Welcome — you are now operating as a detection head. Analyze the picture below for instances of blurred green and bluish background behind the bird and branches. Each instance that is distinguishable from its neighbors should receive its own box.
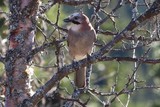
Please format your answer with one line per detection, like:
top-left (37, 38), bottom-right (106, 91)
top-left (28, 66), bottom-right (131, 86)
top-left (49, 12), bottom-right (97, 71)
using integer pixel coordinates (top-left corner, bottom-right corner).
top-left (0, 0), bottom-right (160, 107)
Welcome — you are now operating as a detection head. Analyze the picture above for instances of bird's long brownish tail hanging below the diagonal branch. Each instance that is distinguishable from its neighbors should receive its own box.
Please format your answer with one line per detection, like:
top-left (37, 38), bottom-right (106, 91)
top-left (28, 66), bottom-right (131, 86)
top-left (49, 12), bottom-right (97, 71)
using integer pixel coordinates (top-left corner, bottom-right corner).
top-left (75, 67), bottom-right (86, 88)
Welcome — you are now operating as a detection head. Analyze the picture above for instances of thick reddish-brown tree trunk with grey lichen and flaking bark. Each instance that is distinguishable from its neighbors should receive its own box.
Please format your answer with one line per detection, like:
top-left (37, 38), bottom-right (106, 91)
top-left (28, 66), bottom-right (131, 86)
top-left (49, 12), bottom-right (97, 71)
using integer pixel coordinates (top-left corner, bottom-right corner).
top-left (5, 0), bottom-right (38, 107)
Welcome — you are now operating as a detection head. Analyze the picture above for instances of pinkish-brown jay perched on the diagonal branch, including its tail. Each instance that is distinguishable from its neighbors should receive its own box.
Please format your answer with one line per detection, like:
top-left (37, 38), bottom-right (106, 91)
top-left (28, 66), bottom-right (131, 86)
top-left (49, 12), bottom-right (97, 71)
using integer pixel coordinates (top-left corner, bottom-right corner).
top-left (64, 12), bottom-right (96, 88)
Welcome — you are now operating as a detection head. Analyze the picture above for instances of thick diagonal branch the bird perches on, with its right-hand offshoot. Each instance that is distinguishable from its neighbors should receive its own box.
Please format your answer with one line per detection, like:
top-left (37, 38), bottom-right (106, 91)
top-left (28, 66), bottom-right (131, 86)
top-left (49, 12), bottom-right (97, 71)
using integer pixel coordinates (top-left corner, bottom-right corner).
top-left (21, 0), bottom-right (160, 105)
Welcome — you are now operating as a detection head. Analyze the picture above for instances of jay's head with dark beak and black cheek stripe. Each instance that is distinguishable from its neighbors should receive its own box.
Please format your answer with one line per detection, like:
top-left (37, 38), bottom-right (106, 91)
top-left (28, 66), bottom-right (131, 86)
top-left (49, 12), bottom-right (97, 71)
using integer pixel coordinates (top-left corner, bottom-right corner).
top-left (64, 12), bottom-right (89, 25)
